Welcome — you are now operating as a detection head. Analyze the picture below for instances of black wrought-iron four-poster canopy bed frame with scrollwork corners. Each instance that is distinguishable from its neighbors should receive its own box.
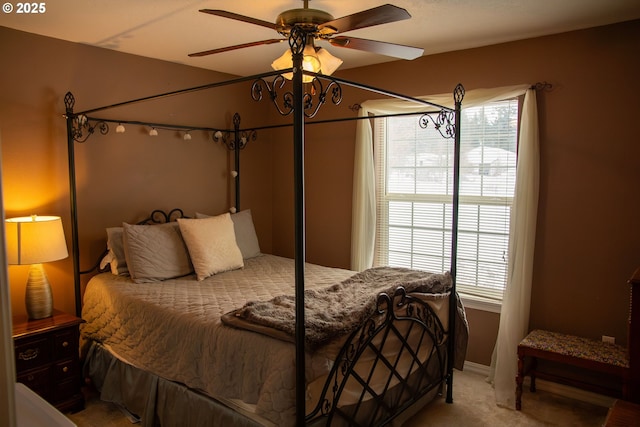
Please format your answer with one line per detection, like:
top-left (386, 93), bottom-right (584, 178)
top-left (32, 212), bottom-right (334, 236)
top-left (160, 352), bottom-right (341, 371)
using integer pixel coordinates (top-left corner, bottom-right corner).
top-left (64, 28), bottom-right (464, 425)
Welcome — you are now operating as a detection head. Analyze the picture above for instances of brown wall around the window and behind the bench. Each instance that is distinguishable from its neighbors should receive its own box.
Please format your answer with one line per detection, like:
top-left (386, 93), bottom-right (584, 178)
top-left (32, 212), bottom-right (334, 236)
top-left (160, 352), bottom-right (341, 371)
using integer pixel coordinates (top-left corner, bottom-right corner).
top-left (274, 21), bottom-right (640, 364)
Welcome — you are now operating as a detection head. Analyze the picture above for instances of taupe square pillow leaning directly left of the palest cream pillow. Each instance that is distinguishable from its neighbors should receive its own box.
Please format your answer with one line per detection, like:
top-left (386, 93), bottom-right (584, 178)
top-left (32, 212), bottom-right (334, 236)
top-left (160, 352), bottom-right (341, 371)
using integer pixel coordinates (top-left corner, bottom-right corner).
top-left (122, 222), bottom-right (193, 283)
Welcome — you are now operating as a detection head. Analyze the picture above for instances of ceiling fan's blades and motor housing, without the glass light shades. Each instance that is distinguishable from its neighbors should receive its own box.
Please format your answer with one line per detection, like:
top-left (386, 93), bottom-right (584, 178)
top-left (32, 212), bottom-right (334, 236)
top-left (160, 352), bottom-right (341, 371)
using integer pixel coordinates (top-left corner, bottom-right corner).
top-left (189, 0), bottom-right (423, 59)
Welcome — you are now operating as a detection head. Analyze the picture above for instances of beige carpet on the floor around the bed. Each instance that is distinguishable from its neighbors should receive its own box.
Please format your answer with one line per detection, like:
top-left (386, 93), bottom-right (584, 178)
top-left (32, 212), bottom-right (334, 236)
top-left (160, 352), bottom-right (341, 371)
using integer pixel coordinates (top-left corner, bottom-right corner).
top-left (67, 371), bottom-right (608, 427)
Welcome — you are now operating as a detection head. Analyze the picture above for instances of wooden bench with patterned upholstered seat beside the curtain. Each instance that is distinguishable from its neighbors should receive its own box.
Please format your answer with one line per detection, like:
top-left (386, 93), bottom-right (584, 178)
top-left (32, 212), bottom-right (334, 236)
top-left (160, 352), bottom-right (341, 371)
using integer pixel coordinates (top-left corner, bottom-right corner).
top-left (516, 330), bottom-right (630, 410)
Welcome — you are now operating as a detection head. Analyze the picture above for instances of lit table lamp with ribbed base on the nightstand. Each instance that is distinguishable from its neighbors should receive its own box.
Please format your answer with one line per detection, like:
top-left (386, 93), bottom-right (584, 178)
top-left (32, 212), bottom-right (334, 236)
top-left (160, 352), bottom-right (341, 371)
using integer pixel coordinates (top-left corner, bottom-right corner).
top-left (5, 215), bottom-right (69, 319)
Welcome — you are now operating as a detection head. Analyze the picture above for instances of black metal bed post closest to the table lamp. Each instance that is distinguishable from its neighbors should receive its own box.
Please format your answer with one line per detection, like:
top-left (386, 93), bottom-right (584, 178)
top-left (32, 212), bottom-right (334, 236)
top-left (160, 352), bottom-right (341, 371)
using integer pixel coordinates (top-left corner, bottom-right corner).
top-left (64, 92), bottom-right (82, 317)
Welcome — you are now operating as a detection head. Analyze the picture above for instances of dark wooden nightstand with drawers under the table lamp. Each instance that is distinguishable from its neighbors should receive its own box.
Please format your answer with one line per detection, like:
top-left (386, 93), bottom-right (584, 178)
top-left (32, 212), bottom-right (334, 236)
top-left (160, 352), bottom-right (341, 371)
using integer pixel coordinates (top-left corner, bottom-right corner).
top-left (13, 310), bottom-right (84, 412)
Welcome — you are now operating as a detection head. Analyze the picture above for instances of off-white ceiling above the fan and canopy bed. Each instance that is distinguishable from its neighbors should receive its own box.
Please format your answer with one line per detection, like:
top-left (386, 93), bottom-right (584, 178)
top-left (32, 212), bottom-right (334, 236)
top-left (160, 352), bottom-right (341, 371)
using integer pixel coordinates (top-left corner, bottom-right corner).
top-left (0, 0), bottom-right (640, 76)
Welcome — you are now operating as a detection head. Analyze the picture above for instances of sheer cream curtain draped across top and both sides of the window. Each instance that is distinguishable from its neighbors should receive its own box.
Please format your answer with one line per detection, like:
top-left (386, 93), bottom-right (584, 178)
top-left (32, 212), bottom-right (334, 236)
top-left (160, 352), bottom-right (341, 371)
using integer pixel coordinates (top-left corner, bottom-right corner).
top-left (351, 85), bottom-right (539, 406)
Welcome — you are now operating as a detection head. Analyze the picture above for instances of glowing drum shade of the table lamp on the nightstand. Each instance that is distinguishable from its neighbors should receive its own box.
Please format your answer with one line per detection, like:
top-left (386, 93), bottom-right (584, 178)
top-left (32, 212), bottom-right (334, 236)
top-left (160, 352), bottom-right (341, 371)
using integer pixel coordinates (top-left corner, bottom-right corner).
top-left (5, 215), bottom-right (69, 265)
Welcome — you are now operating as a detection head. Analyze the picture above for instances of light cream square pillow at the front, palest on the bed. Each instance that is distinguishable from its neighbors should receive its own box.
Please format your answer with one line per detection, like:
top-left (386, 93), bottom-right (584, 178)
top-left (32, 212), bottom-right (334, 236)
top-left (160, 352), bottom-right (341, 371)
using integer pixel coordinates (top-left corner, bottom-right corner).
top-left (178, 213), bottom-right (244, 280)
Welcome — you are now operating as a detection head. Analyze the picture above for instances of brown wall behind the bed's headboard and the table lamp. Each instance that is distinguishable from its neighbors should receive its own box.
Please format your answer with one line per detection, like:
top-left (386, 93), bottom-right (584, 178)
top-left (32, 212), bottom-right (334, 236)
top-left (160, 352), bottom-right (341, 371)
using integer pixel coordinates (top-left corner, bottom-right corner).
top-left (0, 27), bottom-right (271, 314)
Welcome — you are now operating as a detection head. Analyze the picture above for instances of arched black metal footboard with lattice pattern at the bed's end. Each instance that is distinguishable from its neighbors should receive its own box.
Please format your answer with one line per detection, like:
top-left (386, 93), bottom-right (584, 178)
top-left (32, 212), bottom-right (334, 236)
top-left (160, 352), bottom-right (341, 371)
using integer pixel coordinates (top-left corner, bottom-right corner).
top-left (306, 287), bottom-right (449, 427)
